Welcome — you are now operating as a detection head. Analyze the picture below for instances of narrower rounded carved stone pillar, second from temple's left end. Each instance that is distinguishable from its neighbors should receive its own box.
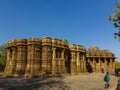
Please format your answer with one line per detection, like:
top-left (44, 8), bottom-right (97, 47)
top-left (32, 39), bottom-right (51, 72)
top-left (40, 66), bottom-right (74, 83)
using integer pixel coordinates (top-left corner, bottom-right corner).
top-left (16, 39), bottom-right (27, 75)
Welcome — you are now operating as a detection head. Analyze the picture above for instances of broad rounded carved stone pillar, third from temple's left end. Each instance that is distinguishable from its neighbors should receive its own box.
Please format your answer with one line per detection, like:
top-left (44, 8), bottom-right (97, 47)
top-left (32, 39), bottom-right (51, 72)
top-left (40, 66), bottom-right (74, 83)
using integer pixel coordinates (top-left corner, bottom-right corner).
top-left (25, 38), bottom-right (42, 76)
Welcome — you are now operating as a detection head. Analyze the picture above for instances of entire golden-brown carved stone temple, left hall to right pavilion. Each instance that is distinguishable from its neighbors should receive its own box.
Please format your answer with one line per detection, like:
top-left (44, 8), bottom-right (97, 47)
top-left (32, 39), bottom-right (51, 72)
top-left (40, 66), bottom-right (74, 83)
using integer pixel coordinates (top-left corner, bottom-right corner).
top-left (4, 37), bottom-right (115, 77)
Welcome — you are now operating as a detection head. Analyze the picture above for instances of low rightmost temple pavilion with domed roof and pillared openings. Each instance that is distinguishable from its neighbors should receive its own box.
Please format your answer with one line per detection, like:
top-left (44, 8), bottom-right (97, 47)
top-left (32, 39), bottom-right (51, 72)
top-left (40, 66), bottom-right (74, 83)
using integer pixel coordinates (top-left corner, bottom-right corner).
top-left (86, 46), bottom-right (115, 73)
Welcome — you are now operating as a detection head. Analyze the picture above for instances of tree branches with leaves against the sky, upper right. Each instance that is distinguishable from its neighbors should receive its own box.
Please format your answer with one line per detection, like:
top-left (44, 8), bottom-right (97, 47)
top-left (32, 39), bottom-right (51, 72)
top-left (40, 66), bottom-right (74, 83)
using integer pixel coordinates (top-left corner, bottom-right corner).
top-left (109, 2), bottom-right (120, 41)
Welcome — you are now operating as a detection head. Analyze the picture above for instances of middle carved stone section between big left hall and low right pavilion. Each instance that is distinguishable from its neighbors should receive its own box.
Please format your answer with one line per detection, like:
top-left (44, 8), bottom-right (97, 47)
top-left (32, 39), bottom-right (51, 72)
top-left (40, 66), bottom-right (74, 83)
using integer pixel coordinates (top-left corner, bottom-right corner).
top-left (69, 44), bottom-right (86, 75)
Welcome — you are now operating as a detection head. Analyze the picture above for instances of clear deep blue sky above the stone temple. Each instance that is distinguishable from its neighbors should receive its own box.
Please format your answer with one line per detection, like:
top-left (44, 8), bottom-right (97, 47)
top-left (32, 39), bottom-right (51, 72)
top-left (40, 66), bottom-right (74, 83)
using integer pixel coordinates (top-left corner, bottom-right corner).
top-left (0, 0), bottom-right (120, 58)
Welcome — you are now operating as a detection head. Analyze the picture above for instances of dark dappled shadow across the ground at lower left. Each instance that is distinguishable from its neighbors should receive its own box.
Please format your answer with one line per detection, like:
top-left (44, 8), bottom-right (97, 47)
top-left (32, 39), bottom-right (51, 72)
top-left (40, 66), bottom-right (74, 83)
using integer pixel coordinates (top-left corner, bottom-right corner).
top-left (0, 76), bottom-right (70, 90)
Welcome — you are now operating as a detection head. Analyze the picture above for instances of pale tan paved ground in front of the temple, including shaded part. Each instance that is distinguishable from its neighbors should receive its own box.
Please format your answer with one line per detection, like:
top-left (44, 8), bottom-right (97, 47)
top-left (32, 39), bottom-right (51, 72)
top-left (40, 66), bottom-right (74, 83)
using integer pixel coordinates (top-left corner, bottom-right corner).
top-left (0, 73), bottom-right (117, 90)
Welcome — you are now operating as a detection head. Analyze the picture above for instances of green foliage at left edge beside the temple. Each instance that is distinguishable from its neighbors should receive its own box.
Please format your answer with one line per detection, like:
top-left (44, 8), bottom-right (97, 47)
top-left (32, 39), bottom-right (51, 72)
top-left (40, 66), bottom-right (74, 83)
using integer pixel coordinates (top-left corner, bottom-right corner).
top-left (0, 44), bottom-right (6, 71)
